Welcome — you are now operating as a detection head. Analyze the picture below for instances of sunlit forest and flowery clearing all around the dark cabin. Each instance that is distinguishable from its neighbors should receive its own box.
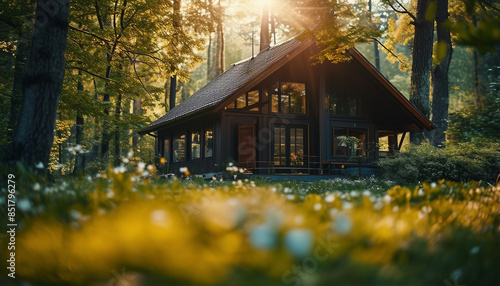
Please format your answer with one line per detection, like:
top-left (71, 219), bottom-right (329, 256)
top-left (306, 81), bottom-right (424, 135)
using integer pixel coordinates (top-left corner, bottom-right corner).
top-left (0, 0), bottom-right (500, 286)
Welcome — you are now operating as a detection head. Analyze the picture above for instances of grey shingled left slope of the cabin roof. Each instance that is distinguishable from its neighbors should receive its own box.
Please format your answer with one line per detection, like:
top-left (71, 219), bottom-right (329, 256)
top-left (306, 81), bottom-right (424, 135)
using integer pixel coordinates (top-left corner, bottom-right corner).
top-left (140, 37), bottom-right (312, 133)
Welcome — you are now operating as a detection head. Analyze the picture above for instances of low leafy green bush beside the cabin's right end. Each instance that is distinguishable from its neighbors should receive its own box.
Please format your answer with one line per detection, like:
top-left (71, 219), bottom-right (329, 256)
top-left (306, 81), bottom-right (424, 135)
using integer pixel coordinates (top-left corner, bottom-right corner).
top-left (379, 142), bottom-right (500, 184)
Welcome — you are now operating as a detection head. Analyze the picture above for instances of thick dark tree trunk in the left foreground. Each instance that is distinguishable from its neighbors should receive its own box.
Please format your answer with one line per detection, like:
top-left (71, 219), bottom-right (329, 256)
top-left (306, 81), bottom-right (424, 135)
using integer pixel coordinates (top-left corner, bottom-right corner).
top-left (11, 0), bottom-right (69, 168)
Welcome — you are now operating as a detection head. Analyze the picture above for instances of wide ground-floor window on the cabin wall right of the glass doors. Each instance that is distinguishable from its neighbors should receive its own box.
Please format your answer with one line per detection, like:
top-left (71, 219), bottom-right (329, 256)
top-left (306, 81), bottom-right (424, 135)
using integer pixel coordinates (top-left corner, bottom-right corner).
top-left (333, 127), bottom-right (368, 157)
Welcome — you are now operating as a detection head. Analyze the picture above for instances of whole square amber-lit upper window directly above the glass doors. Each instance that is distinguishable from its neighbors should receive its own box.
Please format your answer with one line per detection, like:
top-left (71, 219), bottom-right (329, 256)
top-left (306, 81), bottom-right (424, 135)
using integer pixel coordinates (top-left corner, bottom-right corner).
top-left (271, 82), bottom-right (306, 114)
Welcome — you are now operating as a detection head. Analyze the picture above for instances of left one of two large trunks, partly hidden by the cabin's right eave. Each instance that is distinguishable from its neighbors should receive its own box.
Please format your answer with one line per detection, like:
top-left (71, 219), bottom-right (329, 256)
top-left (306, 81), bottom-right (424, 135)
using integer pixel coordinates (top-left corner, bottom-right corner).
top-left (410, 0), bottom-right (434, 145)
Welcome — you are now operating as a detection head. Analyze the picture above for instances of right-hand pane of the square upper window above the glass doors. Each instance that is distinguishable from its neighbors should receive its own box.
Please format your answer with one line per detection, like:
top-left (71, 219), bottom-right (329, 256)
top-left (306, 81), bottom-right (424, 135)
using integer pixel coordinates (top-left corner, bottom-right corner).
top-left (281, 82), bottom-right (306, 114)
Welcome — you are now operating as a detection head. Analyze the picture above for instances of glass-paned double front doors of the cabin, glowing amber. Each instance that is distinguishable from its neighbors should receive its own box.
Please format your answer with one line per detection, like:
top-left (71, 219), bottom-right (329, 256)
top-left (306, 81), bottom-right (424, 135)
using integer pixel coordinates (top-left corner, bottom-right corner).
top-left (272, 125), bottom-right (308, 174)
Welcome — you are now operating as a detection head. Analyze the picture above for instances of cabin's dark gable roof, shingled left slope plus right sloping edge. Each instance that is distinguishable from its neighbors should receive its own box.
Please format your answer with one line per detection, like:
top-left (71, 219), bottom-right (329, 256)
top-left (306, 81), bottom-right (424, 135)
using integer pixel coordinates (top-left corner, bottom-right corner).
top-left (139, 37), bottom-right (435, 134)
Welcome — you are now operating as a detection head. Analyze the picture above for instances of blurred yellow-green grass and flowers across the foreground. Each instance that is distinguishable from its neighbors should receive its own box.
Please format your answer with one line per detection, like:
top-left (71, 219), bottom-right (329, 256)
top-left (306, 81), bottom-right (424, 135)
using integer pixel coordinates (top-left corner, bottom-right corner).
top-left (0, 166), bottom-right (500, 286)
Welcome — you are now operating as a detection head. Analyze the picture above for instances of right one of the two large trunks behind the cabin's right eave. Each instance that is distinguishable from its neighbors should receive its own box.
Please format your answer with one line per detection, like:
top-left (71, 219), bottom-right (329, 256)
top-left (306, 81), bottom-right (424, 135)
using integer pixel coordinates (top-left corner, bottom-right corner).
top-left (430, 0), bottom-right (453, 147)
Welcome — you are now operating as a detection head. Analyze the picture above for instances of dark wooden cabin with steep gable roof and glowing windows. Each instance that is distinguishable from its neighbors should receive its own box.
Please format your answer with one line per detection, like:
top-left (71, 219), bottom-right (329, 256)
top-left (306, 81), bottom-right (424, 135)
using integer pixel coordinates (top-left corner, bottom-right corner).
top-left (140, 38), bottom-right (434, 174)
